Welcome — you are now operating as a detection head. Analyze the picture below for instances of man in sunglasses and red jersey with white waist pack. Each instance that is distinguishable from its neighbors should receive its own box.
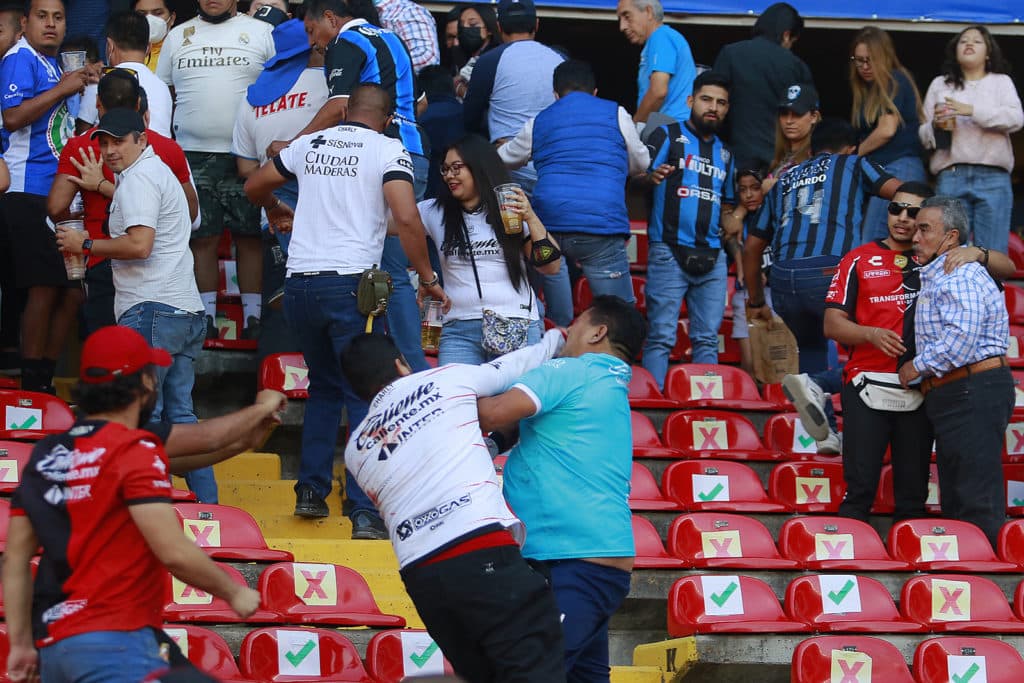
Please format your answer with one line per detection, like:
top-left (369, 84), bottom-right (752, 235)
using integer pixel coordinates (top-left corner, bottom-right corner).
top-left (824, 182), bottom-right (1014, 521)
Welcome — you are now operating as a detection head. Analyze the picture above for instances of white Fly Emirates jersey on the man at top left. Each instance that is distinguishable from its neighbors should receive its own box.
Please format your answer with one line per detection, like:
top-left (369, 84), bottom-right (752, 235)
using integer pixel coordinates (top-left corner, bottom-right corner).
top-left (157, 14), bottom-right (274, 153)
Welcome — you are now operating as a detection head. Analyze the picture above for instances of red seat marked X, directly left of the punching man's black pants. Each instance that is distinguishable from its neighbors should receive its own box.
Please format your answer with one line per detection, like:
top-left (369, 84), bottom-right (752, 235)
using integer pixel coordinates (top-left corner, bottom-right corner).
top-left (259, 562), bottom-right (406, 629)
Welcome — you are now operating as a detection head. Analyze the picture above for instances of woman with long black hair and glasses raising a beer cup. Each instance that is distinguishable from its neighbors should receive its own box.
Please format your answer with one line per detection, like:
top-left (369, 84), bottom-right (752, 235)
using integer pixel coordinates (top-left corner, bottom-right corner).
top-left (419, 135), bottom-right (561, 365)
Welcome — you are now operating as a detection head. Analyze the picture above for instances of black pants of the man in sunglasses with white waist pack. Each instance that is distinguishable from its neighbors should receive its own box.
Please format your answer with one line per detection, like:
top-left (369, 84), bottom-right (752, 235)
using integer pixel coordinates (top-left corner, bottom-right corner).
top-left (839, 383), bottom-right (933, 521)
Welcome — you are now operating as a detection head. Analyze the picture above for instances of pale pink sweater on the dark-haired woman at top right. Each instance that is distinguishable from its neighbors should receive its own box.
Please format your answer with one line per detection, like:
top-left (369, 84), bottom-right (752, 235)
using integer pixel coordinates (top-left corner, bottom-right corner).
top-left (918, 74), bottom-right (1024, 173)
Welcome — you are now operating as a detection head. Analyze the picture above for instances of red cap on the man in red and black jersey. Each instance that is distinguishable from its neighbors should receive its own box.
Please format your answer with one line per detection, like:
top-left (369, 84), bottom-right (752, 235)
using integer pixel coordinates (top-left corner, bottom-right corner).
top-left (79, 325), bottom-right (171, 384)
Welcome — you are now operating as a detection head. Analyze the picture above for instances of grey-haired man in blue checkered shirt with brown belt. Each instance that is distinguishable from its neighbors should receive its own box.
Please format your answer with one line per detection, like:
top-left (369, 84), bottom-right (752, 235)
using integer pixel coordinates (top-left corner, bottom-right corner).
top-left (899, 197), bottom-right (1014, 547)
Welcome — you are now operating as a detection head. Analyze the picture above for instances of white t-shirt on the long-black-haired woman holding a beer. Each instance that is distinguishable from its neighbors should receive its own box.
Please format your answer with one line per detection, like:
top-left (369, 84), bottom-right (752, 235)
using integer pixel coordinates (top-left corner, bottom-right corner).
top-left (418, 200), bottom-right (541, 321)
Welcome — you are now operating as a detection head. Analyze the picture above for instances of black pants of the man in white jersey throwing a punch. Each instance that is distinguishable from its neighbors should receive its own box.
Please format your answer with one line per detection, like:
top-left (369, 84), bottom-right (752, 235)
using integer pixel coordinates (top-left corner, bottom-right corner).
top-left (401, 546), bottom-right (565, 683)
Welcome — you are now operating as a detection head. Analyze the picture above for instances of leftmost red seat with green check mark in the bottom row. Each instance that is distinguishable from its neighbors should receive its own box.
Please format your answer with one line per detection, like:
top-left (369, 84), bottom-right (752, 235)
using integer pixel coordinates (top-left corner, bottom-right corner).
top-left (239, 628), bottom-right (375, 683)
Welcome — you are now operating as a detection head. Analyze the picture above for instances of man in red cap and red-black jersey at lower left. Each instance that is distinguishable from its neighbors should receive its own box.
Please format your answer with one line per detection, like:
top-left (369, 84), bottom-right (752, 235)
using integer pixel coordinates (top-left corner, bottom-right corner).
top-left (3, 327), bottom-right (259, 683)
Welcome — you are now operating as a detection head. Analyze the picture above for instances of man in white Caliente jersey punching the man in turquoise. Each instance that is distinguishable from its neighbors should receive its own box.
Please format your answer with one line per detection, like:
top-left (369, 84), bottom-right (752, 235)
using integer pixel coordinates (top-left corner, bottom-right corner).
top-left (341, 330), bottom-right (565, 683)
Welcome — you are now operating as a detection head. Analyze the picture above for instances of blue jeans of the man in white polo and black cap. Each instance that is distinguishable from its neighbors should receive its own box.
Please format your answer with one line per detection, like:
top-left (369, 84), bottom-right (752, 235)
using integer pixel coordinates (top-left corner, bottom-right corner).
top-left (118, 301), bottom-right (211, 504)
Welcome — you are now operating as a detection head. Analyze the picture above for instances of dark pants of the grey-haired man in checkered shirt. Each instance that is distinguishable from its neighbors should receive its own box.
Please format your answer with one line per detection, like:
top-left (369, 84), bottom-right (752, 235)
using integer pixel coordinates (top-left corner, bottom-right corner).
top-left (925, 368), bottom-right (1014, 548)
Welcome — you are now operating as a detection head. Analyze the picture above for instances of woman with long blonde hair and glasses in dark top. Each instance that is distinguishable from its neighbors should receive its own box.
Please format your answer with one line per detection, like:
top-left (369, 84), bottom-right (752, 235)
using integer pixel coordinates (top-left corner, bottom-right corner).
top-left (850, 27), bottom-right (926, 242)
